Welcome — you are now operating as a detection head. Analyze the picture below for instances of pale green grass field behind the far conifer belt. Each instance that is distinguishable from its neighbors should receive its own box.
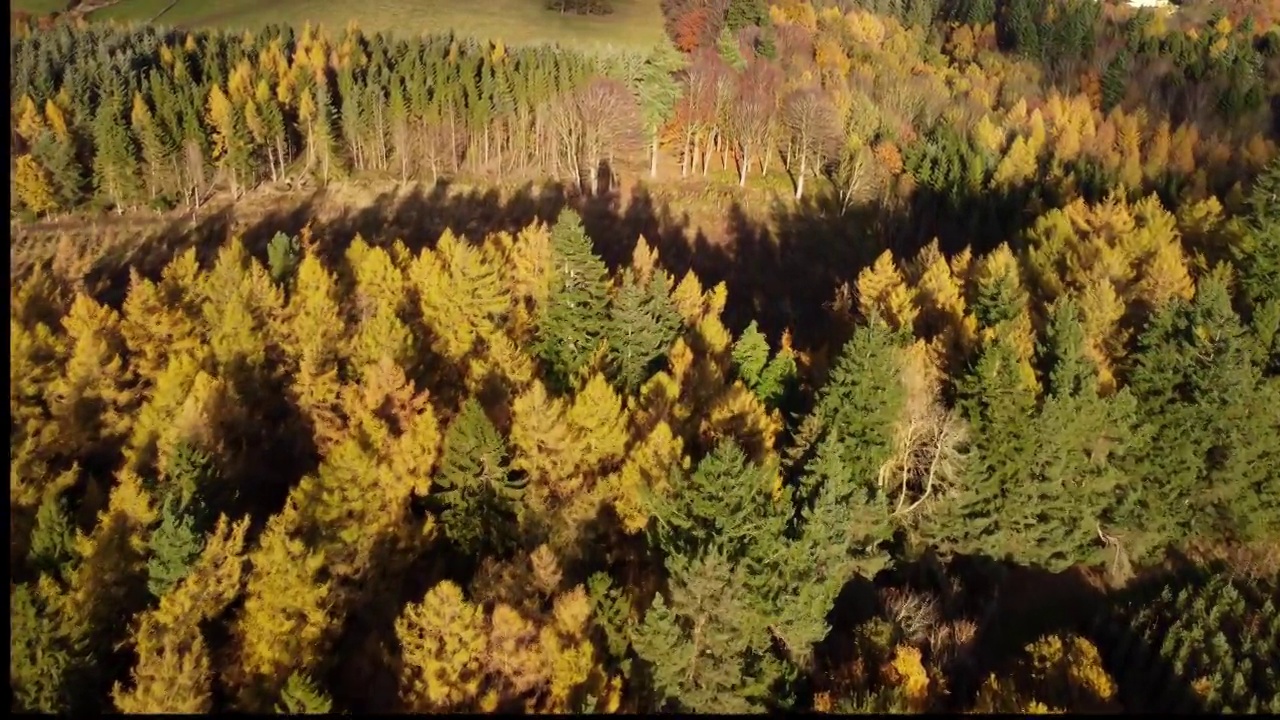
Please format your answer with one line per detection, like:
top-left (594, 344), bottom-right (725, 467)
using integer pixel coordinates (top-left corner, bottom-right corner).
top-left (12, 0), bottom-right (663, 49)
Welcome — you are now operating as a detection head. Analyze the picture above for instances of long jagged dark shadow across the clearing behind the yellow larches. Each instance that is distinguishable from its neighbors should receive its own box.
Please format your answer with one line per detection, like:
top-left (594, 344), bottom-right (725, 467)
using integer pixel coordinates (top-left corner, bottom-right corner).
top-left (91, 171), bottom-right (1049, 348)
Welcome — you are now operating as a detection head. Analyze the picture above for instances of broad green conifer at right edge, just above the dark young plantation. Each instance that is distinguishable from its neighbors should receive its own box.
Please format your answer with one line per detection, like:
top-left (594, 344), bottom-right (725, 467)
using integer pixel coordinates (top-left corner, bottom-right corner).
top-left (1117, 274), bottom-right (1280, 556)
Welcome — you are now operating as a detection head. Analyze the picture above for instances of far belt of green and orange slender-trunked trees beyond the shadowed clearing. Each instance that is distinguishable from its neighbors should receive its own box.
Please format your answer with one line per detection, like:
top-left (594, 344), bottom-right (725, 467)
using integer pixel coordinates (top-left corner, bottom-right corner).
top-left (10, 1), bottom-right (1275, 214)
